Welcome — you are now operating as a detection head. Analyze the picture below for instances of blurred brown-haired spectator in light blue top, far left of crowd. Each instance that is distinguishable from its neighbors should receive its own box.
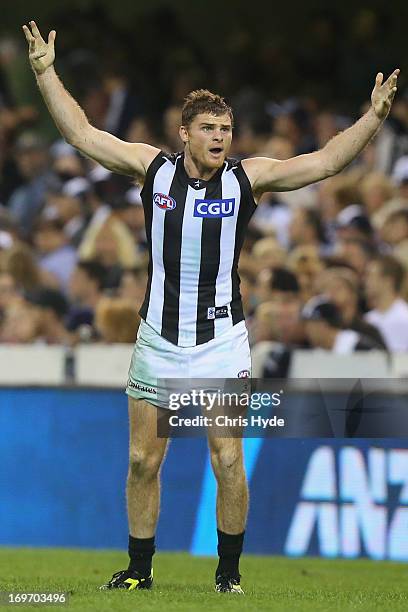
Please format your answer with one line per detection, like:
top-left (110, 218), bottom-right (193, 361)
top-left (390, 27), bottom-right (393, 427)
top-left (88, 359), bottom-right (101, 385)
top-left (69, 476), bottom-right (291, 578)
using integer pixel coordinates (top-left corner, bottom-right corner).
top-left (33, 218), bottom-right (77, 293)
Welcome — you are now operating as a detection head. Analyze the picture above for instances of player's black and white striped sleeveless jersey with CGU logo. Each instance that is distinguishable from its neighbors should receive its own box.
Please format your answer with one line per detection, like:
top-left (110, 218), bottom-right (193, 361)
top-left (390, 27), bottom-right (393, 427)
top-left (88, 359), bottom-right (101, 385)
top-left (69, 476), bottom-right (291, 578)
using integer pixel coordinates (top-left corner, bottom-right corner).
top-left (139, 151), bottom-right (256, 347)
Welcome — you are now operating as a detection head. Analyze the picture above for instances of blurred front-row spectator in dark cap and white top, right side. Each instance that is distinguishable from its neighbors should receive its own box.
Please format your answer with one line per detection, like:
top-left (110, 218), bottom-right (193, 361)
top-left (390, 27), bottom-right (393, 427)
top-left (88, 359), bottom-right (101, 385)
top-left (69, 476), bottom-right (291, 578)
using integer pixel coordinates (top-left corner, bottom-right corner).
top-left (301, 296), bottom-right (378, 355)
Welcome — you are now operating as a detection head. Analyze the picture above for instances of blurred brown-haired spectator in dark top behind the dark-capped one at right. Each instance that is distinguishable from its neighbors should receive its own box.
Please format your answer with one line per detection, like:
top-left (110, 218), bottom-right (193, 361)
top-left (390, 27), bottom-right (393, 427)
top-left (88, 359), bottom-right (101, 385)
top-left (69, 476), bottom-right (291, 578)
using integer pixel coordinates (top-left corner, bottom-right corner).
top-left (317, 267), bottom-right (386, 350)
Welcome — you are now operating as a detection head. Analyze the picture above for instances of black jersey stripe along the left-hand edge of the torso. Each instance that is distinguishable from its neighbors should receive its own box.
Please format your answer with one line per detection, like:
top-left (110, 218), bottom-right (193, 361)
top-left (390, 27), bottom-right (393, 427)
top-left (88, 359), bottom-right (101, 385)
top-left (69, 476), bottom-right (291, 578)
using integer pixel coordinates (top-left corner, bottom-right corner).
top-left (139, 151), bottom-right (167, 319)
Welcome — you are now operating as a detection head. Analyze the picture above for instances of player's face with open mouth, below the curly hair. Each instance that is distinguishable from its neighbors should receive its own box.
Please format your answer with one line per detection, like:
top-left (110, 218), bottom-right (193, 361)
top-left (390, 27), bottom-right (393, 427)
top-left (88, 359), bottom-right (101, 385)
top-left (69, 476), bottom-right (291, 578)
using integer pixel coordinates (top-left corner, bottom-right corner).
top-left (180, 113), bottom-right (232, 169)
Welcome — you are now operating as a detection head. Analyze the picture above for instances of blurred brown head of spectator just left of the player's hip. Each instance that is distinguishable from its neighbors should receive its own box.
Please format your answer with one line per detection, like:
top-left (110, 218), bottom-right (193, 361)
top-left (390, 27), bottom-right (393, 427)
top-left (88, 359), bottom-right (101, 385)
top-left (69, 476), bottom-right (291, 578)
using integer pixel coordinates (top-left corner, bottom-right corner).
top-left (95, 297), bottom-right (140, 344)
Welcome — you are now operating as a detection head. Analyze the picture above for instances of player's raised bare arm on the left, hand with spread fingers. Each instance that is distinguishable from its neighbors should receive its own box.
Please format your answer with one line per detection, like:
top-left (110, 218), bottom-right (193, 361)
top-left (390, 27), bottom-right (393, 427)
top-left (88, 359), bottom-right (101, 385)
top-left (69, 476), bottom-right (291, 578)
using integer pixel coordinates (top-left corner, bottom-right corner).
top-left (23, 21), bottom-right (159, 180)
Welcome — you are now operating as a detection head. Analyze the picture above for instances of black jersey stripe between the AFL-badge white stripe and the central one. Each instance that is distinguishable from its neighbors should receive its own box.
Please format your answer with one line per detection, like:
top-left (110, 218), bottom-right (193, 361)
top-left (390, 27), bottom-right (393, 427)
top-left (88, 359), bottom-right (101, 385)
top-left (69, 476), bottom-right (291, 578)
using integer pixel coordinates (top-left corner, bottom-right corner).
top-left (161, 157), bottom-right (188, 344)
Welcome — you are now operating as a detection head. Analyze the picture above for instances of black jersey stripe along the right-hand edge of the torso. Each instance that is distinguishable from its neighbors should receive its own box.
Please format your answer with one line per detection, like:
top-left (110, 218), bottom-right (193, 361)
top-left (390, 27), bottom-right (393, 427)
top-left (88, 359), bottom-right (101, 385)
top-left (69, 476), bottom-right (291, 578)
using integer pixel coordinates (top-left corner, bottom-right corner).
top-left (231, 162), bottom-right (256, 325)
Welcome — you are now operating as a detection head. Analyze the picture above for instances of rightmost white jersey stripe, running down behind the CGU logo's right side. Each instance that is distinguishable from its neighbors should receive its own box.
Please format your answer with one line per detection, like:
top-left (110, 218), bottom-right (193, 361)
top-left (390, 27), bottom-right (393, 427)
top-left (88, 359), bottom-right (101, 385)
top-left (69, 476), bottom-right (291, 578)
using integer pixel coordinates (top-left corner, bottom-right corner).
top-left (214, 165), bottom-right (241, 336)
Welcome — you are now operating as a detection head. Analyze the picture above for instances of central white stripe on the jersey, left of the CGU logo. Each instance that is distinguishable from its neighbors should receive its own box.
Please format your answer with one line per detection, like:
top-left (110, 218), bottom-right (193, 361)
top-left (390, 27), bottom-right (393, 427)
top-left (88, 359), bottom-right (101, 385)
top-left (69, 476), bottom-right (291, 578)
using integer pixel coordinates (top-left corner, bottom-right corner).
top-left (179, 185), bottom-right (206, 346)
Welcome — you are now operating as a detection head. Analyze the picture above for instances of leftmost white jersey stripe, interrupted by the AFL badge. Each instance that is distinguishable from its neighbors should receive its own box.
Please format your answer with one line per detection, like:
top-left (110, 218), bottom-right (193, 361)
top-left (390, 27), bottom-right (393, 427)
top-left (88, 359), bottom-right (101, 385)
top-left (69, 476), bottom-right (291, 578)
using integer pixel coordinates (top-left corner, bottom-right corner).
top-left (146, 158), bottom-right (178, 333)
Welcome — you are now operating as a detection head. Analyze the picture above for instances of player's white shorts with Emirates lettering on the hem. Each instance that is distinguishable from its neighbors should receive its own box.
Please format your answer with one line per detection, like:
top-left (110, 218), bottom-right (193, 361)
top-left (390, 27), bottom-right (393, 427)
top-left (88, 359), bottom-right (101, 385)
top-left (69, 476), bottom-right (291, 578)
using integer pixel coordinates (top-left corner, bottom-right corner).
top-left (126, 319), bottom-right (251, 408)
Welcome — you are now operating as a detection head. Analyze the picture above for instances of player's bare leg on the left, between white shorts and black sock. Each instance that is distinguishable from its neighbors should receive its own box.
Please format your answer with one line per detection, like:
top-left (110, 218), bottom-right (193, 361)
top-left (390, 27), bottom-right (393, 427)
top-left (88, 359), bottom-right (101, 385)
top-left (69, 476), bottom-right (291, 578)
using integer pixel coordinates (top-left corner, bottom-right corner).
top-left (126, 397), bottom-right (168, 538)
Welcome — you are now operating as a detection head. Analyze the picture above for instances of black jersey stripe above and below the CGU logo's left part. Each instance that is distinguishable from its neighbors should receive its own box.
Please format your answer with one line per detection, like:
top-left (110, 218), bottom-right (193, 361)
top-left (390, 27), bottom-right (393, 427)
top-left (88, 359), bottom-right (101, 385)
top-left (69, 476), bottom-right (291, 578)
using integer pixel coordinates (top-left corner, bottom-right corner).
top-left (196, 178), bottom-right (222, 344)
